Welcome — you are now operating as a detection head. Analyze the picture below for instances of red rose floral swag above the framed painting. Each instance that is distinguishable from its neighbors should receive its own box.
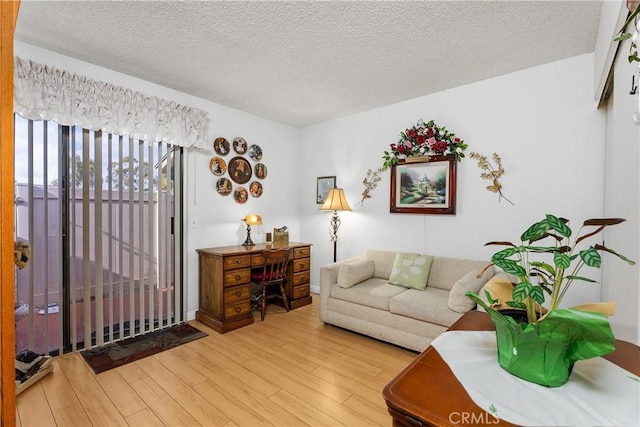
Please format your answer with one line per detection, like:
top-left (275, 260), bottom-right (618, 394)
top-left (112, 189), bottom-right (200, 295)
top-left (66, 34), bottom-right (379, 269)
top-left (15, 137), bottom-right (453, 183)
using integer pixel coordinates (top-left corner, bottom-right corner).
top-left (382, 119), bottom-right (467, 169)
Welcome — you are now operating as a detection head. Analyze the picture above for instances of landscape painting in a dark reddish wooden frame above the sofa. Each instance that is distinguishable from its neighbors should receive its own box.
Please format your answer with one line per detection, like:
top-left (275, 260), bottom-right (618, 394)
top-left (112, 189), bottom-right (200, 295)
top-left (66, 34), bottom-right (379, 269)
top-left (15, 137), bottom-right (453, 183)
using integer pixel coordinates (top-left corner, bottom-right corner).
top-left (389, 155), bottom-right (457, 215)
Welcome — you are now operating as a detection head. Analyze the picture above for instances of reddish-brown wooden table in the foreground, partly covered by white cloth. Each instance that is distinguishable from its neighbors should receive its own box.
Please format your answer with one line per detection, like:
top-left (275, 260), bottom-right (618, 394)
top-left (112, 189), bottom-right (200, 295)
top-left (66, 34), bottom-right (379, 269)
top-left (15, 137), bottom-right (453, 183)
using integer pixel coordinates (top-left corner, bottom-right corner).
top-left (382, 311), bottom-right (640, 427)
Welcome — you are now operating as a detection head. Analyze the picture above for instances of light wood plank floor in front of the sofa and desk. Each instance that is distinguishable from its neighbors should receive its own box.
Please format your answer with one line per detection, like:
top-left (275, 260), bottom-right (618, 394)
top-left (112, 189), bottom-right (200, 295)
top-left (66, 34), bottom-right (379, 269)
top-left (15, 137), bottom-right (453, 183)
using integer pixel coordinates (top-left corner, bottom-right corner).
top-left (16, 295), bottom-right (417, 427)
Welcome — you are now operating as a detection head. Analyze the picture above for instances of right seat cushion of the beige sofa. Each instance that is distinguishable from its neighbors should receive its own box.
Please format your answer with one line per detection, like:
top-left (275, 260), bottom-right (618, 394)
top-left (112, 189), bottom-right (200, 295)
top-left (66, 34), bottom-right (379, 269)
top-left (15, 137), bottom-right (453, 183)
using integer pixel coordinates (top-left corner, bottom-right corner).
top-left (389, 287), bottom-right (462, 327)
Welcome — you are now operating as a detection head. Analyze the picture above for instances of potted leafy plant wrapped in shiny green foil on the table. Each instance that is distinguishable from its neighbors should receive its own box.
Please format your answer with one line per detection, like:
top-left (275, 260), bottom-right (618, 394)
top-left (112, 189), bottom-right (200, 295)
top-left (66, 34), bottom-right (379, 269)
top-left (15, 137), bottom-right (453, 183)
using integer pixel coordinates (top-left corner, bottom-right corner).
top-left (466, 214), bottom-right (635, 386)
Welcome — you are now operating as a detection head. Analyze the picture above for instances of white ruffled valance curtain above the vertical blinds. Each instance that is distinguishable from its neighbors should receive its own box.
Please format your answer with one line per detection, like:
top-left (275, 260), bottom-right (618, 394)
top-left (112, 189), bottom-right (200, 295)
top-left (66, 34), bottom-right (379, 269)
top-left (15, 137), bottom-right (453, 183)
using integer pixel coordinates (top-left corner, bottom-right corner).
top-left (14, 57), bottom-right (212, 150)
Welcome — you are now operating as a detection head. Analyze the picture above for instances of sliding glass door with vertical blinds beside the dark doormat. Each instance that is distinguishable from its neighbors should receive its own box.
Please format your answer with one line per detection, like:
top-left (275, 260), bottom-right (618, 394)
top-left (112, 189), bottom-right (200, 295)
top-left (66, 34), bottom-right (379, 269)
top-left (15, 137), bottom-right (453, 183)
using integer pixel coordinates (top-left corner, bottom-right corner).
top-left (15, 115), bottom-right (185, 353)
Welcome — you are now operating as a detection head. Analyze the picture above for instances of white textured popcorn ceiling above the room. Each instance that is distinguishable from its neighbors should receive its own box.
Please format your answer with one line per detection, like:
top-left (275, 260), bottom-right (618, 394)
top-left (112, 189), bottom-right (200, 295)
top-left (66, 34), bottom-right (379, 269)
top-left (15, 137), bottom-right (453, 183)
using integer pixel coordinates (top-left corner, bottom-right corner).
top-left (16, 0), bottom-right (602, 127)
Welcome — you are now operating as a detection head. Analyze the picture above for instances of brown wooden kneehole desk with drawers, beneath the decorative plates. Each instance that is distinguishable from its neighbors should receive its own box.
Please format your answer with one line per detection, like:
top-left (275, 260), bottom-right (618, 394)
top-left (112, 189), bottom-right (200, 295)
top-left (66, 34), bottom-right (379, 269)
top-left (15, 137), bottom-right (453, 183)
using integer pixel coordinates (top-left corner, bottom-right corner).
top-left (196, 242), bottom-right (311, 334)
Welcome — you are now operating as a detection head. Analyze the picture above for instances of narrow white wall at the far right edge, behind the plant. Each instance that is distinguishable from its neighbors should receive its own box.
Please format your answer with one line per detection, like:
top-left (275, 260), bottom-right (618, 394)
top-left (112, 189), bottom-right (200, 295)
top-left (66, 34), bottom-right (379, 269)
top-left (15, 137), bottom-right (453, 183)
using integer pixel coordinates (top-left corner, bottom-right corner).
top-left (602, 36), bottom-right (640, 343)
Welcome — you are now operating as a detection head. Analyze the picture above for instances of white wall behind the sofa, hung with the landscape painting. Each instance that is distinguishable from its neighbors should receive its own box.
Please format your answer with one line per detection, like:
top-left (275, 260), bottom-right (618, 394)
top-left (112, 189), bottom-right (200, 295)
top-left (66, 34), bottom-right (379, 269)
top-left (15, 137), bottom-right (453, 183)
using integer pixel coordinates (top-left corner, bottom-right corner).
top-left (301, 54), bottom-right (605, 305)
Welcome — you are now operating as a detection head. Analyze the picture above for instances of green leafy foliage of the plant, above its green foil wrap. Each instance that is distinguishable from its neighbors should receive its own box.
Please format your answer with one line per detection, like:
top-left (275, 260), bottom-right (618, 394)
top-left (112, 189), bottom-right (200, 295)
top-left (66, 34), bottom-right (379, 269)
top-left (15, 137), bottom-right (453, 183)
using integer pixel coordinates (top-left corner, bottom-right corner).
top-left (478, 214), bottom-right (635, 323)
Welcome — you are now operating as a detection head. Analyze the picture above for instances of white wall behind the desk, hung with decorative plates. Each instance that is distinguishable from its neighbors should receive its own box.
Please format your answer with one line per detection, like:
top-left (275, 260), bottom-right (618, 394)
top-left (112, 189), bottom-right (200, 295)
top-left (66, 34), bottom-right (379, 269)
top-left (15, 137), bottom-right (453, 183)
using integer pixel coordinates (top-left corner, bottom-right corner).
top-left (15, 42), bottom-right (301, 318)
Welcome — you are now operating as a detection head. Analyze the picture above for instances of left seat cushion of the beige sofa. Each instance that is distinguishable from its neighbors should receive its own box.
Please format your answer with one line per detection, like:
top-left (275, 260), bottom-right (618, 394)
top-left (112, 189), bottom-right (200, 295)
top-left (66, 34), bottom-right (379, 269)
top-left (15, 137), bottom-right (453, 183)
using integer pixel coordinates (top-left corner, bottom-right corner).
top-left (331, 277), bottom-right (404, 310)
